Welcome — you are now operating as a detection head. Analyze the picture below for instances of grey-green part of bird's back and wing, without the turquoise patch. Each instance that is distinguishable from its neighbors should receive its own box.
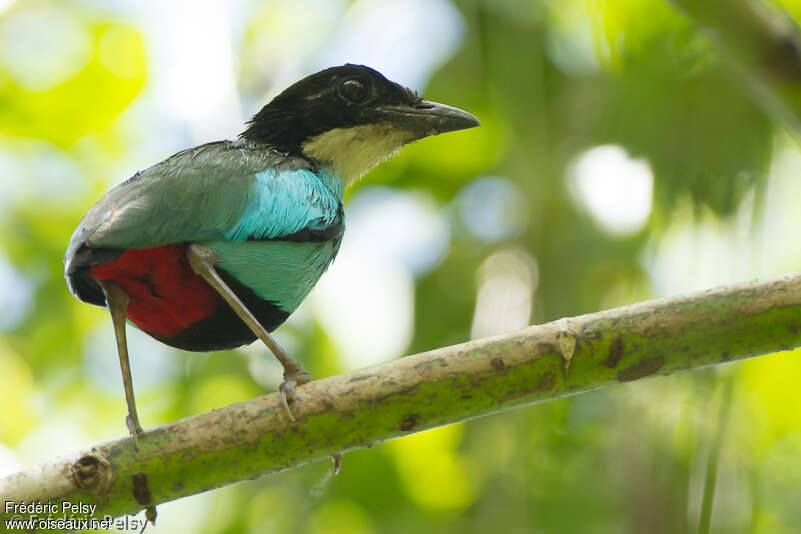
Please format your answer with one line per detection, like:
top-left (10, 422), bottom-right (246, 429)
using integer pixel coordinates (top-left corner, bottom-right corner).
top-left (64, 141), bottom-right (309, 305)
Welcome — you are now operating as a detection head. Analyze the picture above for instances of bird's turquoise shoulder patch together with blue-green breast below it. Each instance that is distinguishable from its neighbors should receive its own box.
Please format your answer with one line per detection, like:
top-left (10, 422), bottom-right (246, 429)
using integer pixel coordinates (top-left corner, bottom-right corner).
top-left (206, 169), bottom-right (344, 312)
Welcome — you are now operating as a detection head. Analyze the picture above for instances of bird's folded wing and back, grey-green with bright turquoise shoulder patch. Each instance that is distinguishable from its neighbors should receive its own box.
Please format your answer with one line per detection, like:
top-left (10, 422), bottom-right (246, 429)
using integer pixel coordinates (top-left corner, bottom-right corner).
top-left (65, 141), bottom-right (341, 310)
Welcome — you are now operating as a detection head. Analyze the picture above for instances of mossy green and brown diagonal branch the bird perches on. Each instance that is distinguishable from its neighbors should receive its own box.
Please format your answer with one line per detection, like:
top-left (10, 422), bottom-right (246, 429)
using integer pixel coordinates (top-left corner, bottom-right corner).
top-left (0, 274), bottom-right (801, 529)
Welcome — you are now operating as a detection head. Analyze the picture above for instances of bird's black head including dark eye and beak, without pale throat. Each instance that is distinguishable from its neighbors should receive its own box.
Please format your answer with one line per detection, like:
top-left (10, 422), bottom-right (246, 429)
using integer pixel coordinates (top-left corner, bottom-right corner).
top-left (240, 64), bottom-right (479, 174)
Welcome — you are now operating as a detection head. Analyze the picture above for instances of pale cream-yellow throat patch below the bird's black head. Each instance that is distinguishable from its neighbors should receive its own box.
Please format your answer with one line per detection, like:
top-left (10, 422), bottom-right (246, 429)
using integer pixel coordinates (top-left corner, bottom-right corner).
top-left (303, 123), bottom-right (414, 185)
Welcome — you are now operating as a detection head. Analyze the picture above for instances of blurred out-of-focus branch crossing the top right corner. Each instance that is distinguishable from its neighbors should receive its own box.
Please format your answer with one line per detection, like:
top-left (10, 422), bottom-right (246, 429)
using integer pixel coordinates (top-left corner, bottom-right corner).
top-left (672, 0), bottom-right (801, 137)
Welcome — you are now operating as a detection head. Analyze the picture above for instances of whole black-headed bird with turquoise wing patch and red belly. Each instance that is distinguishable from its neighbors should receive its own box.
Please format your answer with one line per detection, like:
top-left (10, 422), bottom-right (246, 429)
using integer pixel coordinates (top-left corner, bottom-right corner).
top-left (64, 64), bottom-right (479, 448)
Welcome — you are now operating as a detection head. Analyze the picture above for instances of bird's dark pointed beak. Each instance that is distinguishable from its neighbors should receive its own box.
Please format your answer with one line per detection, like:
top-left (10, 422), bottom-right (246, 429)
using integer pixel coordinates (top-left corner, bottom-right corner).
top-left (376, 100), bottom-right (481, 139)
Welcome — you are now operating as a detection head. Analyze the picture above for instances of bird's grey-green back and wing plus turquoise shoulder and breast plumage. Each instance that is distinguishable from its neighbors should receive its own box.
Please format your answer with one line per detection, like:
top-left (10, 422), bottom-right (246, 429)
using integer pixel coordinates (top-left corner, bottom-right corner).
top-left (65, 141), bottom-right (344, 312)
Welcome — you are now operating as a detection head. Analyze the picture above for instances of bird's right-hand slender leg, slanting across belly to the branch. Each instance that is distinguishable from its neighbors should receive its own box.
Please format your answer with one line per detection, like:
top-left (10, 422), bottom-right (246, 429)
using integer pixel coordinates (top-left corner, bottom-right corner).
top-left (186, 243), bottom-right (311, 421)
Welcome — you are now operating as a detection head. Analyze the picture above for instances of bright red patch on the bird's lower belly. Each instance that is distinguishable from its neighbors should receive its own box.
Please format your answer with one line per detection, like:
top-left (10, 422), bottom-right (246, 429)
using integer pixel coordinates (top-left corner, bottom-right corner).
top-left (90, 244), bottom-right (223, 337)
